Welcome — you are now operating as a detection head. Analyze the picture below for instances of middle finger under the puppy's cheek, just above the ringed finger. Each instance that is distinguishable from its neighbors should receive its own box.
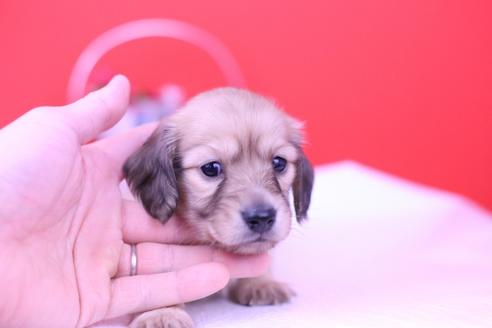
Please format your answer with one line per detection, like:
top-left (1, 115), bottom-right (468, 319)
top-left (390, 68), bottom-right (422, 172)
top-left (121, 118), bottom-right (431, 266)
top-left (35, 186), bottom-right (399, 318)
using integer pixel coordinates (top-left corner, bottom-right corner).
top-left (122, 200), bottom-right (196, 244)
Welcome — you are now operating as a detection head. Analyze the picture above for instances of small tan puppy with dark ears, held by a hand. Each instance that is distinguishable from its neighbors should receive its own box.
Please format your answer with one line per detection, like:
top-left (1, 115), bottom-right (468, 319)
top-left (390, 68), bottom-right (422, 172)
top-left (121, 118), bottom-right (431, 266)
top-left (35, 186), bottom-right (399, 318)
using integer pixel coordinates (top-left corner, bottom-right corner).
top-left (124, 88), bottom-right (314, 327)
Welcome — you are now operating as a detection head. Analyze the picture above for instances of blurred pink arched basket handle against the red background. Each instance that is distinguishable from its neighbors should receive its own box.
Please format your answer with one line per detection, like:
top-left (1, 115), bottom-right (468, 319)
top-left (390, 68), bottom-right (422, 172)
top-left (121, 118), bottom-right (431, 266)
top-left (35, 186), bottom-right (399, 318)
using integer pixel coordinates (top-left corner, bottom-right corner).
top-left (67, 18), bottom-right (245, 102)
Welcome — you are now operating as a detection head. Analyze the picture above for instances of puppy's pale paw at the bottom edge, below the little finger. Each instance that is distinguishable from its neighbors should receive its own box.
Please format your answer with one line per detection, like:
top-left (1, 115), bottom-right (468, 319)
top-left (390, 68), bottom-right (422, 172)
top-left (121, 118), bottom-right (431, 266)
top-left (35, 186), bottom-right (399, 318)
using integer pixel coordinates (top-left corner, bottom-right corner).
top-left (129, 306), bottom-right (195, 328)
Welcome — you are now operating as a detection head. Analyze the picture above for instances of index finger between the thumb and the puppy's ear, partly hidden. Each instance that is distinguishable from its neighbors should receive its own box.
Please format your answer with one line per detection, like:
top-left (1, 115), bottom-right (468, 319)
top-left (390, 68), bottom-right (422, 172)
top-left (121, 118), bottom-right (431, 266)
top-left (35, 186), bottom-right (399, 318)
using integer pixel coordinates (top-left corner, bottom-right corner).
top-left (92, 122), bottom-right (158, 179)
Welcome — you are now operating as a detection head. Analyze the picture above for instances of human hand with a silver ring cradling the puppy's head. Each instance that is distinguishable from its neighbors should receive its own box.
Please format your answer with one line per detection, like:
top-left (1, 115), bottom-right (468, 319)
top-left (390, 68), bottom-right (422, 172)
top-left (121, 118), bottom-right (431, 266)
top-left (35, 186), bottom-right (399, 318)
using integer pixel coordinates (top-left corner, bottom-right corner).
top-left (0, 76), bottom-right (268, 327)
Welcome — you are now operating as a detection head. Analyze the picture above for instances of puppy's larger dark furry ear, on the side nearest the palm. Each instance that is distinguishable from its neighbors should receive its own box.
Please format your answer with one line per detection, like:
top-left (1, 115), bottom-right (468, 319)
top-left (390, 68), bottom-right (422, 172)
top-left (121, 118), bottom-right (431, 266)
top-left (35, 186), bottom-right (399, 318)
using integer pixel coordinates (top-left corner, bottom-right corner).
top-left (123, 126), bottom-right (179, 222)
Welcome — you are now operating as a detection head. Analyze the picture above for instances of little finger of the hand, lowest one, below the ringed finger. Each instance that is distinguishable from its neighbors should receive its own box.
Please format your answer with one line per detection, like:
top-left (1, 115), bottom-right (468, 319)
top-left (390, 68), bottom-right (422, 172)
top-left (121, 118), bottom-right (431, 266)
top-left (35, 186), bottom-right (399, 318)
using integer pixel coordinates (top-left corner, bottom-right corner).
top-left (106, 263), bottom-right (229, 318)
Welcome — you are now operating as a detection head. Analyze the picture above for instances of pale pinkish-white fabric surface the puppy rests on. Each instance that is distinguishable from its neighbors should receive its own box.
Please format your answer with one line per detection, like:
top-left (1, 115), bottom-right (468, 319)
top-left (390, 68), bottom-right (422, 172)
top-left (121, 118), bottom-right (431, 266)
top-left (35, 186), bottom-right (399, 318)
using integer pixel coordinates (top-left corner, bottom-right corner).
top-left (97, 162), bottom-right (492, 328)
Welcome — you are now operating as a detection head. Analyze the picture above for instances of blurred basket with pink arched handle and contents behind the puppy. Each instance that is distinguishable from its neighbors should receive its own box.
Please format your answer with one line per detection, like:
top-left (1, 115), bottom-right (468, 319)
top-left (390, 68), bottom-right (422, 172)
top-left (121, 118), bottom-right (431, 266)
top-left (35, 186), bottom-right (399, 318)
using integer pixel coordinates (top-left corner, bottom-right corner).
top-left (67, 19), bottom-right (245, 136)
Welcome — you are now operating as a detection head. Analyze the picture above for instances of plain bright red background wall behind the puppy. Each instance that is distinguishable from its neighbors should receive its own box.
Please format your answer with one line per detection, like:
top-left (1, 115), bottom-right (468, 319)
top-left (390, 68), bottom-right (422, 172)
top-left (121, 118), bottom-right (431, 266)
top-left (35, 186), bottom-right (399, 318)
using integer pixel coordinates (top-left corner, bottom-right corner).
top-left (0, 0), bottom-right (492, 208)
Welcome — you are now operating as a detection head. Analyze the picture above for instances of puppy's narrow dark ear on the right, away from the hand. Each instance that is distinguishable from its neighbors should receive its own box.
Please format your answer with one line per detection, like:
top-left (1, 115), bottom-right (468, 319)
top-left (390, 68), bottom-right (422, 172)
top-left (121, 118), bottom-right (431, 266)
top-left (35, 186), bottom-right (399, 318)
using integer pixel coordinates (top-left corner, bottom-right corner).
top-left (292, 150), bottom-right (314, 222)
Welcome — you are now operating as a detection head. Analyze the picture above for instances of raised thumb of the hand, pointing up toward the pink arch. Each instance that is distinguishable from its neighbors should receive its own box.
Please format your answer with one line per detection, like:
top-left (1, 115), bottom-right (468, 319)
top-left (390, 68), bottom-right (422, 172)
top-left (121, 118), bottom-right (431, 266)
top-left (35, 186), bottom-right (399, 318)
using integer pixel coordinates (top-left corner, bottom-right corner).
top-left (62, 75), bottom-right (130, 144)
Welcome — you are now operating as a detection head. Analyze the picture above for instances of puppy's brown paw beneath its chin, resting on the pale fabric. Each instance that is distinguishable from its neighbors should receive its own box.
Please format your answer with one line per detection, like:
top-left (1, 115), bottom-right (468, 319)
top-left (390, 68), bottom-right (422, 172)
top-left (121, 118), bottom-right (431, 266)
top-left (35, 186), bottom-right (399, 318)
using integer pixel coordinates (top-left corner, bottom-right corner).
top-left (229, 278), bottom-right (295, 306)
